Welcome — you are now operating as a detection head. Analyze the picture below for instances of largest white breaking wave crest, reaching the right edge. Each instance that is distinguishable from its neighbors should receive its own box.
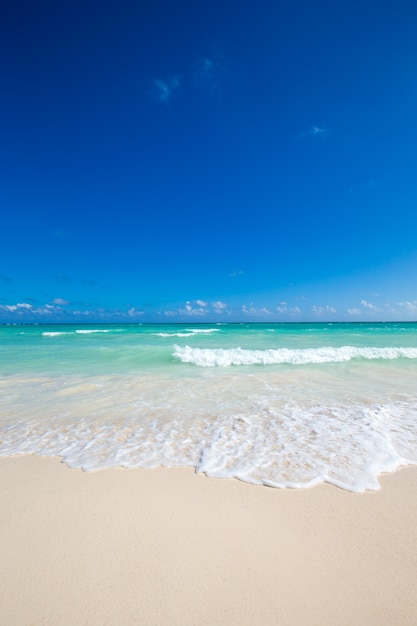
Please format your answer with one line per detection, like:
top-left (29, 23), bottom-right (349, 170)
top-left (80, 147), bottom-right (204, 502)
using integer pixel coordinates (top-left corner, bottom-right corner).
top-left (173, 346), bottom-right (417, 367)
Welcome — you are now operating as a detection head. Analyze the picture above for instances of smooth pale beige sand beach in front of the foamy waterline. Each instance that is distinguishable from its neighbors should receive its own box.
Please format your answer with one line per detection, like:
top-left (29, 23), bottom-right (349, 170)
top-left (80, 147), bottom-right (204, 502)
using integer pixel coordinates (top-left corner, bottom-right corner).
top-left (0, 457), bottom-right (417, 626)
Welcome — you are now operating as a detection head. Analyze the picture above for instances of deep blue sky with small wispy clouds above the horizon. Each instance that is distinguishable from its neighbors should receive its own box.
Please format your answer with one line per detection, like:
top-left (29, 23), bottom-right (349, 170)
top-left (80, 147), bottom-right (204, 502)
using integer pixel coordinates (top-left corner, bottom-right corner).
top-left (0, 0), bottom-right (417, 323)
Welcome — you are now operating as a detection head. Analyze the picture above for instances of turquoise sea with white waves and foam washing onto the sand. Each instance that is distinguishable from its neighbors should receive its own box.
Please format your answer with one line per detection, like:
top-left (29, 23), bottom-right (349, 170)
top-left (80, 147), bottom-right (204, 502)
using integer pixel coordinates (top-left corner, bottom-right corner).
top-left (0, 322), bottom-right (417, 492)
